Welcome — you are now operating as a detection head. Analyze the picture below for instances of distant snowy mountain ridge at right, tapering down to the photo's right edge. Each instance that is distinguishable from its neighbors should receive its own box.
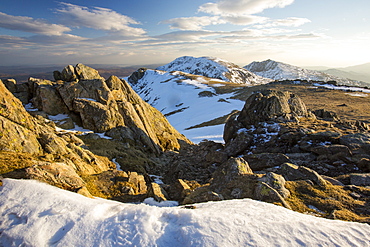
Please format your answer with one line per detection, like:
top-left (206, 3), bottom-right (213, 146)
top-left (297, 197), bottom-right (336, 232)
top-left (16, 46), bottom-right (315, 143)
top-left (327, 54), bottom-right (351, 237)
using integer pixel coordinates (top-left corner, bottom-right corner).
top-left (244, 59), bottom-right (369, 86)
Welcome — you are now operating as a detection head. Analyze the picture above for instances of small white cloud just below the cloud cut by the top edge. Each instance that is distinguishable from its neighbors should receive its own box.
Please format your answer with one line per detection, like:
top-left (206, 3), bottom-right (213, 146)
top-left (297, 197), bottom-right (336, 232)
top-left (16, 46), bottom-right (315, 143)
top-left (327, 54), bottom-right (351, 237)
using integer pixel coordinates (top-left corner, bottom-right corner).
top-left (161, 16), bottom-right (226, 30)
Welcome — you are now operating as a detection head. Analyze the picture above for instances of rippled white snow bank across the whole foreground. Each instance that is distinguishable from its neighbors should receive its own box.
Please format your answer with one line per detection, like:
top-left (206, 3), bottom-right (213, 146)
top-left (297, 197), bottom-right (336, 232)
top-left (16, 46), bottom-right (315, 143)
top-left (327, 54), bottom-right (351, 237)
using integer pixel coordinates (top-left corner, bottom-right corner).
top-left (0, 179), bottom-right (370, 247)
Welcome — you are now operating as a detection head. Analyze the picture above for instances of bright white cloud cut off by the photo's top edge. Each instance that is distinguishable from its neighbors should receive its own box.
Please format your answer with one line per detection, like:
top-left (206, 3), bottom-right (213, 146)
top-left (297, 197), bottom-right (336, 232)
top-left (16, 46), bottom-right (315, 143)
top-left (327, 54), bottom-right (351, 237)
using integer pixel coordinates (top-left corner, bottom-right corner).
top-left (198, 0), bottom-right (294, 16)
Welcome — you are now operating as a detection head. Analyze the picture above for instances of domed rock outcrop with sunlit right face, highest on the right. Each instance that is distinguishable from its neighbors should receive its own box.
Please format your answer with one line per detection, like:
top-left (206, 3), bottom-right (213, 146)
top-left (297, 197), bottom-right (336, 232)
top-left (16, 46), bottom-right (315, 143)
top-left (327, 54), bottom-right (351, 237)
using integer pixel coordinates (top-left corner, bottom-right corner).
top-left (238, 90), bottom-right (309, 127)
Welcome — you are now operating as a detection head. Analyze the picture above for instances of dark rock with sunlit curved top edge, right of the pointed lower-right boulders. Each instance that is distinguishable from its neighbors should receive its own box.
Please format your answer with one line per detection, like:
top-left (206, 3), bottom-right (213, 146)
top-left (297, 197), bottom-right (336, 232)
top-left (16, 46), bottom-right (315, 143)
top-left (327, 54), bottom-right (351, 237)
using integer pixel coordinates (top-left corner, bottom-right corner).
top-left (279, 163), bottom-right (326, 186)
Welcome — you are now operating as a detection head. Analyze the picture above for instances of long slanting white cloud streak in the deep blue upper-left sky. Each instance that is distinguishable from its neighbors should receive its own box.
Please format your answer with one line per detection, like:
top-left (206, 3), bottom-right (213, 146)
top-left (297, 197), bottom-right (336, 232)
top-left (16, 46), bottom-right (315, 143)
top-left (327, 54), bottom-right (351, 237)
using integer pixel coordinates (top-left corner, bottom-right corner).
top-left (57, 3), bottom-right (146, 36)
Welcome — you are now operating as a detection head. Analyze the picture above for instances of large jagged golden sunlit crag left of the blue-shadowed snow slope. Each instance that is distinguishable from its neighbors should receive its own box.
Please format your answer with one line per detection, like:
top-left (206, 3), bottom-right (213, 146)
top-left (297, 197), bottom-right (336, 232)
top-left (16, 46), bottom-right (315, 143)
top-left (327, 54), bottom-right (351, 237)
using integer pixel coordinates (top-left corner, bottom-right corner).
top-left (33, 64), bottom-right (189, 154)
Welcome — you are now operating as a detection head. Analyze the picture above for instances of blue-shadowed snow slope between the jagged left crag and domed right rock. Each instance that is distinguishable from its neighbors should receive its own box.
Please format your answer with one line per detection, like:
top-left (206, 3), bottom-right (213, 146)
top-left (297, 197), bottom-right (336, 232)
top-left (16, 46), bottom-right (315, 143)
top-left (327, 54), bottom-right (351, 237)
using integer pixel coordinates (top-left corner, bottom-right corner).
top-left (128, 69), bottom-right (244, 143)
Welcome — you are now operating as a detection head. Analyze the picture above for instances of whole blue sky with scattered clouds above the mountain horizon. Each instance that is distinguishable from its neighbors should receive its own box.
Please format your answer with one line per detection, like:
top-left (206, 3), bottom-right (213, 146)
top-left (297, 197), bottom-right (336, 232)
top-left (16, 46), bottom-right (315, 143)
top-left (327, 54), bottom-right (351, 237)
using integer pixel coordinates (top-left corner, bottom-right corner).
top-left (0, 0), bottom-right (370, 67)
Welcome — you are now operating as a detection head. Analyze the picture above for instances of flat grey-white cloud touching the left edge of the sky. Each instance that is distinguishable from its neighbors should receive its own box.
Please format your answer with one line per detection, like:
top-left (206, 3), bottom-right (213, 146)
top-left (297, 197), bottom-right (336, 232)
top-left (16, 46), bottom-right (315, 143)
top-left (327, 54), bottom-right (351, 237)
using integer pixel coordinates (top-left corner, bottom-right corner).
top-left (0, 12), bottom-right (71, 35)
